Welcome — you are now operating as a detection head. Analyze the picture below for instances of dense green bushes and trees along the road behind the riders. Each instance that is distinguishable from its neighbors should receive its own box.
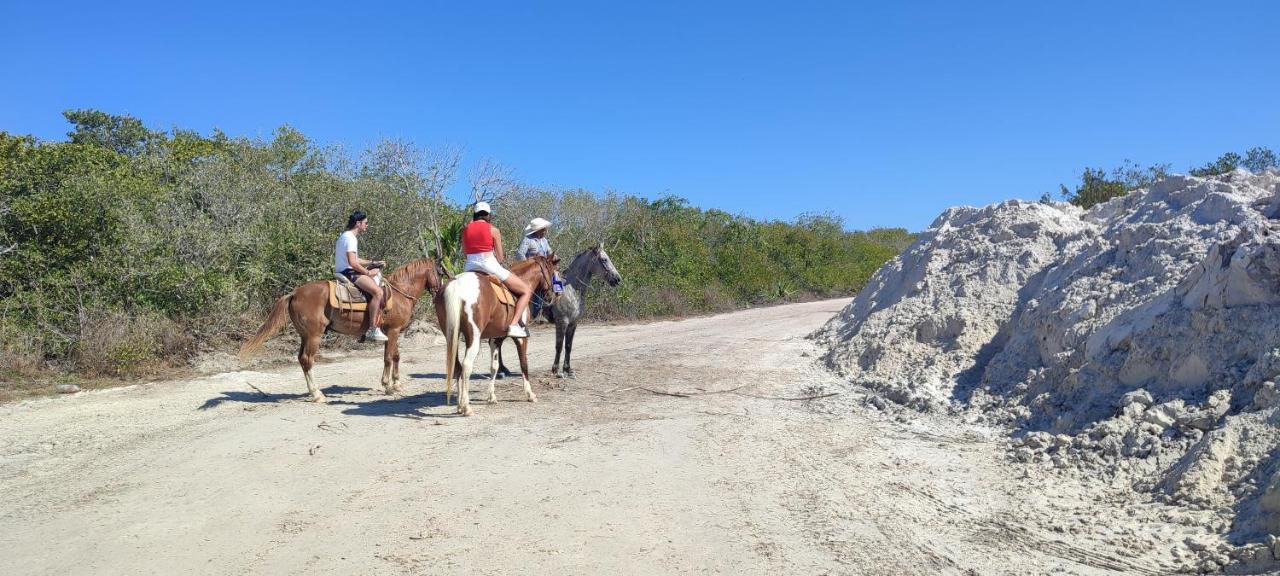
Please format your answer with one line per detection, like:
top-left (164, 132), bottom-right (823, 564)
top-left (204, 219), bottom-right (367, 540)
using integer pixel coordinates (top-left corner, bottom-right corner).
top-left (0, 110), bottom-right (911, 381)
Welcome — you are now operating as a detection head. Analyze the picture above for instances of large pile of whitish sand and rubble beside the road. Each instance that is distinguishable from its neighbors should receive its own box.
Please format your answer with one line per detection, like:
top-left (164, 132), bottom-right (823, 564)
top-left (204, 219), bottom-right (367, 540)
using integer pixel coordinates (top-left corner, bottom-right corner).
top-left (815, 170), bottom-right (1280, 570)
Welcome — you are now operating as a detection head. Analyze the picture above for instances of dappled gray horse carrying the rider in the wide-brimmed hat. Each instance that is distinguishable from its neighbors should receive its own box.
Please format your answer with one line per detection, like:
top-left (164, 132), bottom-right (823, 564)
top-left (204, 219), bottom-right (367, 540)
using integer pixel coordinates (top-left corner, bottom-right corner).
top-left (490, 243), bottom-right (622, 378)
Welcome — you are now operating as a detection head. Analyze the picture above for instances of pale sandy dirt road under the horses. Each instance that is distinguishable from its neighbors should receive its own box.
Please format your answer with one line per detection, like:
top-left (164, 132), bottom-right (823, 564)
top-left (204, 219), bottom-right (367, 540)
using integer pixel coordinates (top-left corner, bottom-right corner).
top-left (0, 301), bottom-right (1174, 575)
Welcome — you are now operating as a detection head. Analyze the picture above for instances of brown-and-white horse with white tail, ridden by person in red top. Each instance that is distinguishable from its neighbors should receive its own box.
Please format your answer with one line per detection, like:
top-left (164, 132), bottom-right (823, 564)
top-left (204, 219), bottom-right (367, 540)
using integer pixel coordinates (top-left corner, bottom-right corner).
top-left (433, 255), bottom-right (559, 416)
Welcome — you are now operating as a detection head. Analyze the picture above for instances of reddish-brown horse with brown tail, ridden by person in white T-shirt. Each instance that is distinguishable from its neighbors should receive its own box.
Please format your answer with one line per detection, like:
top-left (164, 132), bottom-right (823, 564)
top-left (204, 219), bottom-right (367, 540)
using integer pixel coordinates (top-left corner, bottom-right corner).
top-left (241, 259), bottom-right (440, 402)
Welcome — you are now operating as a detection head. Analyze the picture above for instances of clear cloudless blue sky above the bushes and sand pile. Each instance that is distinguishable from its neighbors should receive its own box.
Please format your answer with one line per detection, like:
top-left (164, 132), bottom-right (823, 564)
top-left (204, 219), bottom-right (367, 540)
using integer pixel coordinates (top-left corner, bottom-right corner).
top-left (0, 0), bottom-right (1280, 230)
